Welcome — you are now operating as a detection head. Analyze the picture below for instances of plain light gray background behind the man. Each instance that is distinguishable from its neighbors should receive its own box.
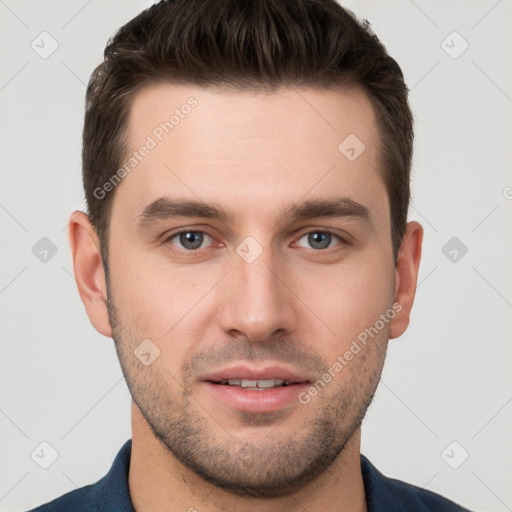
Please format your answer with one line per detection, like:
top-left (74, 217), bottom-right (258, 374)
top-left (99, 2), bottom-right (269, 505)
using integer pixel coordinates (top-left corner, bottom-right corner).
top-left (0, 0), bottom-right (512, 512)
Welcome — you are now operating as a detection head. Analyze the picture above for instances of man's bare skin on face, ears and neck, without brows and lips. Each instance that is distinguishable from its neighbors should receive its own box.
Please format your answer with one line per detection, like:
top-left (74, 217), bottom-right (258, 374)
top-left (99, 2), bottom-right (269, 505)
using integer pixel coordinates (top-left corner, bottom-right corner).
top-left (69, 84), bottom-right (423, 512)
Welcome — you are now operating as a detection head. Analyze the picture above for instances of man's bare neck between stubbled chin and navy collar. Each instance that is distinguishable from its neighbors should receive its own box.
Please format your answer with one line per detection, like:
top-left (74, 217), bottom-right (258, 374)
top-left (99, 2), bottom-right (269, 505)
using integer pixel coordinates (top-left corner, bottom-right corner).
top-left (128, 402), bottom-right (366, 512)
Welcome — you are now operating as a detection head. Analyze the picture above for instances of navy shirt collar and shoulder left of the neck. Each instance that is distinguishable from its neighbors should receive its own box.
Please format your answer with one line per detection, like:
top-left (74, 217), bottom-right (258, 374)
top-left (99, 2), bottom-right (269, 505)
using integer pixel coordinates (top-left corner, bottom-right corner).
top-left (28, 439), bottom-right (134, 512)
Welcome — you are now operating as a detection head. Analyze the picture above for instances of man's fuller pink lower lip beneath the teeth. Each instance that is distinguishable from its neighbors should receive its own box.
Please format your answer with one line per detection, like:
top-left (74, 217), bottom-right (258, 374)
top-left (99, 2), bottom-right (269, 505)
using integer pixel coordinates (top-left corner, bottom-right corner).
top-left (204, 381), bottom-right (308, 412)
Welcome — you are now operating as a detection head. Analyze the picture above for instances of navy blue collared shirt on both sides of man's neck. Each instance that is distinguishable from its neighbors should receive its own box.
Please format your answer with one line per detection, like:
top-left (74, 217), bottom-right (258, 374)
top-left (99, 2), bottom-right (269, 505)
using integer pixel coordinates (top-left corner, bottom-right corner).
top-left (26, 439), bottom-right (468, 512)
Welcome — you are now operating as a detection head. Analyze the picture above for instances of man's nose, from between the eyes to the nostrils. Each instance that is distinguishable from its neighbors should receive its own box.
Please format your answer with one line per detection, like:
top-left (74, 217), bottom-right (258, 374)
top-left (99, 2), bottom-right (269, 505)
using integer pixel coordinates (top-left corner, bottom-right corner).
top-left (218, 242), bottom-right (297, 341)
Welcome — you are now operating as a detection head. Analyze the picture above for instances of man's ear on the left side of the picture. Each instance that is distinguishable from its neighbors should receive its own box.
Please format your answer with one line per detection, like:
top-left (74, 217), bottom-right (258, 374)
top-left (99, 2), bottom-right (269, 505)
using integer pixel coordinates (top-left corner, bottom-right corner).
top-left (68, 210), bottom-right (112, 338)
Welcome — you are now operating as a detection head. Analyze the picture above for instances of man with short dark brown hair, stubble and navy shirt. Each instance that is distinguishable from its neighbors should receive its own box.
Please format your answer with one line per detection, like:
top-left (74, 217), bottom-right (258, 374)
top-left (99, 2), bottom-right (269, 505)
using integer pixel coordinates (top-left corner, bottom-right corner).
top-left (29, 0), bottom-right (472, 512)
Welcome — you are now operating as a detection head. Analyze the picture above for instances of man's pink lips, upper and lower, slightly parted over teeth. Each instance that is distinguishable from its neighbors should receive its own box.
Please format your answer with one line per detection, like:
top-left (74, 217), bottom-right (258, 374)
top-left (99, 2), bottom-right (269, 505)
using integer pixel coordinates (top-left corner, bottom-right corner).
top-left (200, 365), bottom-right (311, 413)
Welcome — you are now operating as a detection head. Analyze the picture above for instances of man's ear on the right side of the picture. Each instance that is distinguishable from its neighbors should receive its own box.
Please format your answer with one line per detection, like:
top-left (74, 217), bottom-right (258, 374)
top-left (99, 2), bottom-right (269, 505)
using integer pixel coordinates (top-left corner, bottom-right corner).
top-left (390, 221), bottom-right (423, 338)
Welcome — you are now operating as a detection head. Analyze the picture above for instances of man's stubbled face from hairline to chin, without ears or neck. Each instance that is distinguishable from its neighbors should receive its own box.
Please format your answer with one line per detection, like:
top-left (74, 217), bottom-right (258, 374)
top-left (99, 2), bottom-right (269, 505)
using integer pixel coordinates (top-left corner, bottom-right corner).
top-left (109, 85), bottom-right (395, 496)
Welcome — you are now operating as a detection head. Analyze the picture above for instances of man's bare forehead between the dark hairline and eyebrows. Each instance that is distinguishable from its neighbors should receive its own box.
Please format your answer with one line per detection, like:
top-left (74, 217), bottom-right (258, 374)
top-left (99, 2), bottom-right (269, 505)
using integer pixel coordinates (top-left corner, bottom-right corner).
top-left (114, 84), bottom-right (387, 228)
